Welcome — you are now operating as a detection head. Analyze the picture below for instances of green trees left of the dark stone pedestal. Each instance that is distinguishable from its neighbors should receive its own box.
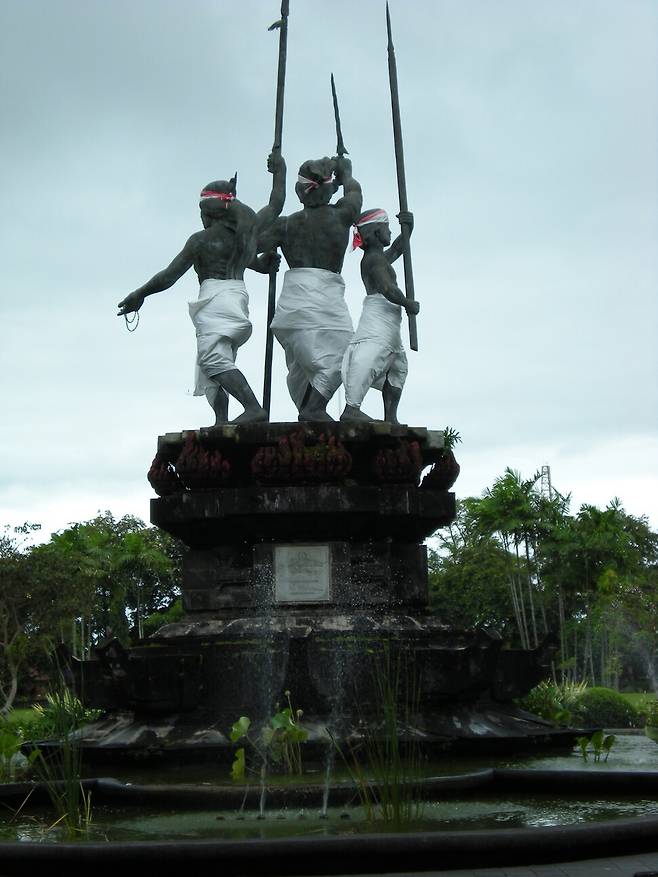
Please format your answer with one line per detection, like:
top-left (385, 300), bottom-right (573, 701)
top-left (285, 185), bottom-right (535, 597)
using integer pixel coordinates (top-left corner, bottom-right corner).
top-left (0, 512), bottom-right (182, 714)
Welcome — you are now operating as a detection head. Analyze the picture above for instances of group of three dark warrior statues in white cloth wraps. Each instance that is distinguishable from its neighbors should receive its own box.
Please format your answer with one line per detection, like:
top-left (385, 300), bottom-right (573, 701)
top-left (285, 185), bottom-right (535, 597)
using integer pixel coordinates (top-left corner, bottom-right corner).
top-left (119, 2), bottom-right (419, 424)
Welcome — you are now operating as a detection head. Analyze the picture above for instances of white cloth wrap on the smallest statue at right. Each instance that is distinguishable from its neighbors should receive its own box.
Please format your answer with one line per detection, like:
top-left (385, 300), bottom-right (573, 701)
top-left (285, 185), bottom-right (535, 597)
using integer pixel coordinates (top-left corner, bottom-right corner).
top-left (342, 292), bottom-right (408, 408)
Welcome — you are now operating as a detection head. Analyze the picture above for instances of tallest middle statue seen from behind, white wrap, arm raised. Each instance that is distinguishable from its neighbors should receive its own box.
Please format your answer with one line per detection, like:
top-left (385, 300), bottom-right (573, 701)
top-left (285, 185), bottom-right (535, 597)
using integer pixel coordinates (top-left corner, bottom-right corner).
top-left (258, 155), bottom-right (363, 421)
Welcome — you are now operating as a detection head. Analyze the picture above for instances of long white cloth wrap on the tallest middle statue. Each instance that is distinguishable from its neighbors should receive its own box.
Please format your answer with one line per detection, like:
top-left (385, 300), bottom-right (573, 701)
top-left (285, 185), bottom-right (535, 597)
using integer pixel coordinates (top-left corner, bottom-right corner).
top-left (271, 268), bottom-right (354, 410)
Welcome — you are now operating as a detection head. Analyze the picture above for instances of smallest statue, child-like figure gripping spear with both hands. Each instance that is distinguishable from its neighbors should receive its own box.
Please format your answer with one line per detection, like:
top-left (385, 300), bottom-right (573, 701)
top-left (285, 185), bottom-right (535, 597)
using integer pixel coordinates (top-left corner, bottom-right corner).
top-left (340, 209), bottom-right (420, 423)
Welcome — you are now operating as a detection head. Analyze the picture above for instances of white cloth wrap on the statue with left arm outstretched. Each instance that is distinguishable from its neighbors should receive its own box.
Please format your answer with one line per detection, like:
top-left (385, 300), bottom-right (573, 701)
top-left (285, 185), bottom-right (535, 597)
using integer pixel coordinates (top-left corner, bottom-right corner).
top-left (188, 280), bottom-right (251, 399)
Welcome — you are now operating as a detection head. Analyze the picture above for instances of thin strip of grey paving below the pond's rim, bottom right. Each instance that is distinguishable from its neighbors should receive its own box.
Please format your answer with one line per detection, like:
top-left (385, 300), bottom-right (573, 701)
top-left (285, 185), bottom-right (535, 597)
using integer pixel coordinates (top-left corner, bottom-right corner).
top-left (336, 852), bottom-right (658, 877)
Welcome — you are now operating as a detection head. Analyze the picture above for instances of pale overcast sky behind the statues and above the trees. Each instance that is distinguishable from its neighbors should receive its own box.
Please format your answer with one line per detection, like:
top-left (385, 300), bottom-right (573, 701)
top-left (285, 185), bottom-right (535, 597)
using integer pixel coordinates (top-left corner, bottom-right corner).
top-left (0, 0), bottom-right (658, 536)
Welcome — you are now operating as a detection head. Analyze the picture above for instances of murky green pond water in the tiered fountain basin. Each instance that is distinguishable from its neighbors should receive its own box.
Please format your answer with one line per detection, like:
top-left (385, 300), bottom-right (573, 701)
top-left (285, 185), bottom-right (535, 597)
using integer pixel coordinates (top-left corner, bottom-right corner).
top-left (0, 735), bottom-right (658, 842)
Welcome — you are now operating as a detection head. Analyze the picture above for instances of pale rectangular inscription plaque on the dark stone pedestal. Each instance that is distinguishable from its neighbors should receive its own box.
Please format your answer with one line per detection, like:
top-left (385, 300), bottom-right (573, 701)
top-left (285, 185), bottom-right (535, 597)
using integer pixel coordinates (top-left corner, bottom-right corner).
top-left (274, 545), bottom-right (331, 603)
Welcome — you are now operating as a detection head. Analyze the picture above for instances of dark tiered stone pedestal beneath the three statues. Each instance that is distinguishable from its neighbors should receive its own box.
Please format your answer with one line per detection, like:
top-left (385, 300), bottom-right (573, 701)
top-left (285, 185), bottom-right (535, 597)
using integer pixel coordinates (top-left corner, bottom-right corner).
top-left (69, 422), bottom-right (573, 757)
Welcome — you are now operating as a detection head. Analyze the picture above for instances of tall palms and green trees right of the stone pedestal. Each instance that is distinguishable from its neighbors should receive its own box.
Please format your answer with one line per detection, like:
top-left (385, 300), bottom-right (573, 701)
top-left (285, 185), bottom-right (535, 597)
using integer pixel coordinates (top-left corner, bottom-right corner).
top-left (430, 469), bottom-right (658, 691)
